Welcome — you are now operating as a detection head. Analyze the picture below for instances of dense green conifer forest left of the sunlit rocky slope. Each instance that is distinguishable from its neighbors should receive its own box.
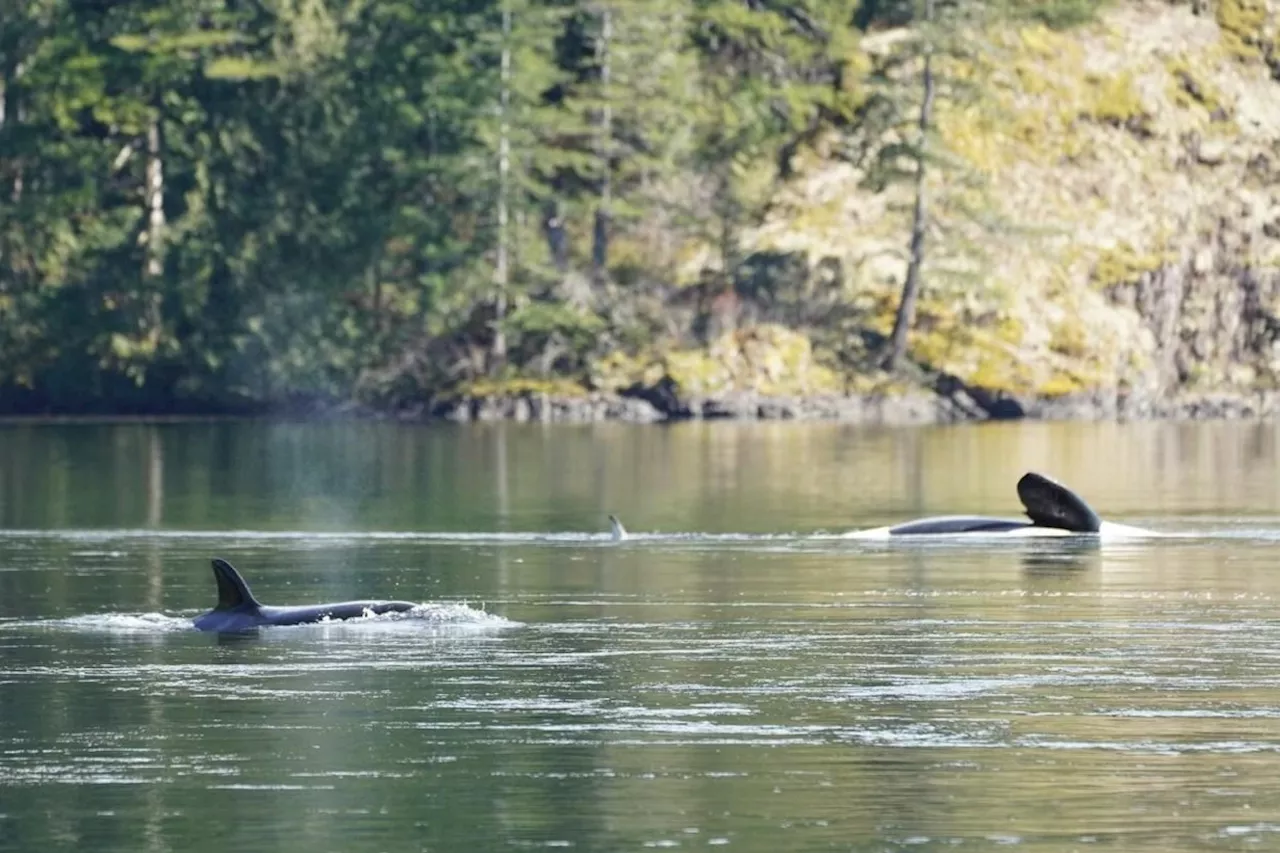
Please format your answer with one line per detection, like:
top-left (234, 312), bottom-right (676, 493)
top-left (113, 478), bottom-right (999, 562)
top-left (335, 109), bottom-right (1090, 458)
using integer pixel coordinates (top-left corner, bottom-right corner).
top-left (0, 0), bottom-right (1249, 411)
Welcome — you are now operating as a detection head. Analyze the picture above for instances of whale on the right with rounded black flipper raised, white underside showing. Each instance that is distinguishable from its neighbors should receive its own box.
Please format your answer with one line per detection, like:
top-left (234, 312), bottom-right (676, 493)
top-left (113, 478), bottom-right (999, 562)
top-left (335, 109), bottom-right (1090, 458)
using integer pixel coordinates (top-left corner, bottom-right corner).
top-left (845, 471), bottom-right (1155, 539)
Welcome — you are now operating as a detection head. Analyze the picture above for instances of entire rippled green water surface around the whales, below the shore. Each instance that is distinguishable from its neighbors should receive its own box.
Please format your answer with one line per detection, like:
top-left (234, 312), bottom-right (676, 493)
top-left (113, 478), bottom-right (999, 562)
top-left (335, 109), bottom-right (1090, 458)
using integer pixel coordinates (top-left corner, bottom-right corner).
top-left (0, 423), bottom-right (1280, 853)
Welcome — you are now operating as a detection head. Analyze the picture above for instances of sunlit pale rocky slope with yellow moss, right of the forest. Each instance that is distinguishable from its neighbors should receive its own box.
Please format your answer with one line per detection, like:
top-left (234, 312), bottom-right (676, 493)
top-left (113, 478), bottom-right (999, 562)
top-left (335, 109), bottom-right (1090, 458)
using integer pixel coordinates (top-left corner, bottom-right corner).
top-left (732, 0), bottom-right (1280, 415)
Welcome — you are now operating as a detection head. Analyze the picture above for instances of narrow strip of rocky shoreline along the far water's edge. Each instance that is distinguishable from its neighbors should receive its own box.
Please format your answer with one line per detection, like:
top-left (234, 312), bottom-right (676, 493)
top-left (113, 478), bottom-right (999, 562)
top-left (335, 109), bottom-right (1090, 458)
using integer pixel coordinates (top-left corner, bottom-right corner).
top-left (0, 387), bottom-right (1280, 427)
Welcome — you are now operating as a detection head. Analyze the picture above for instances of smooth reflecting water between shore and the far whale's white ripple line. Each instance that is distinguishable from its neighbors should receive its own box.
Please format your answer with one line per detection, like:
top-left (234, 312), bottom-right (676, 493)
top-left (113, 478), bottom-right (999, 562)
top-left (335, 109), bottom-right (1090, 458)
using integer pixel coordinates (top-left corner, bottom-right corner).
top-left (0, 421), bottom-right (1280, 533)
